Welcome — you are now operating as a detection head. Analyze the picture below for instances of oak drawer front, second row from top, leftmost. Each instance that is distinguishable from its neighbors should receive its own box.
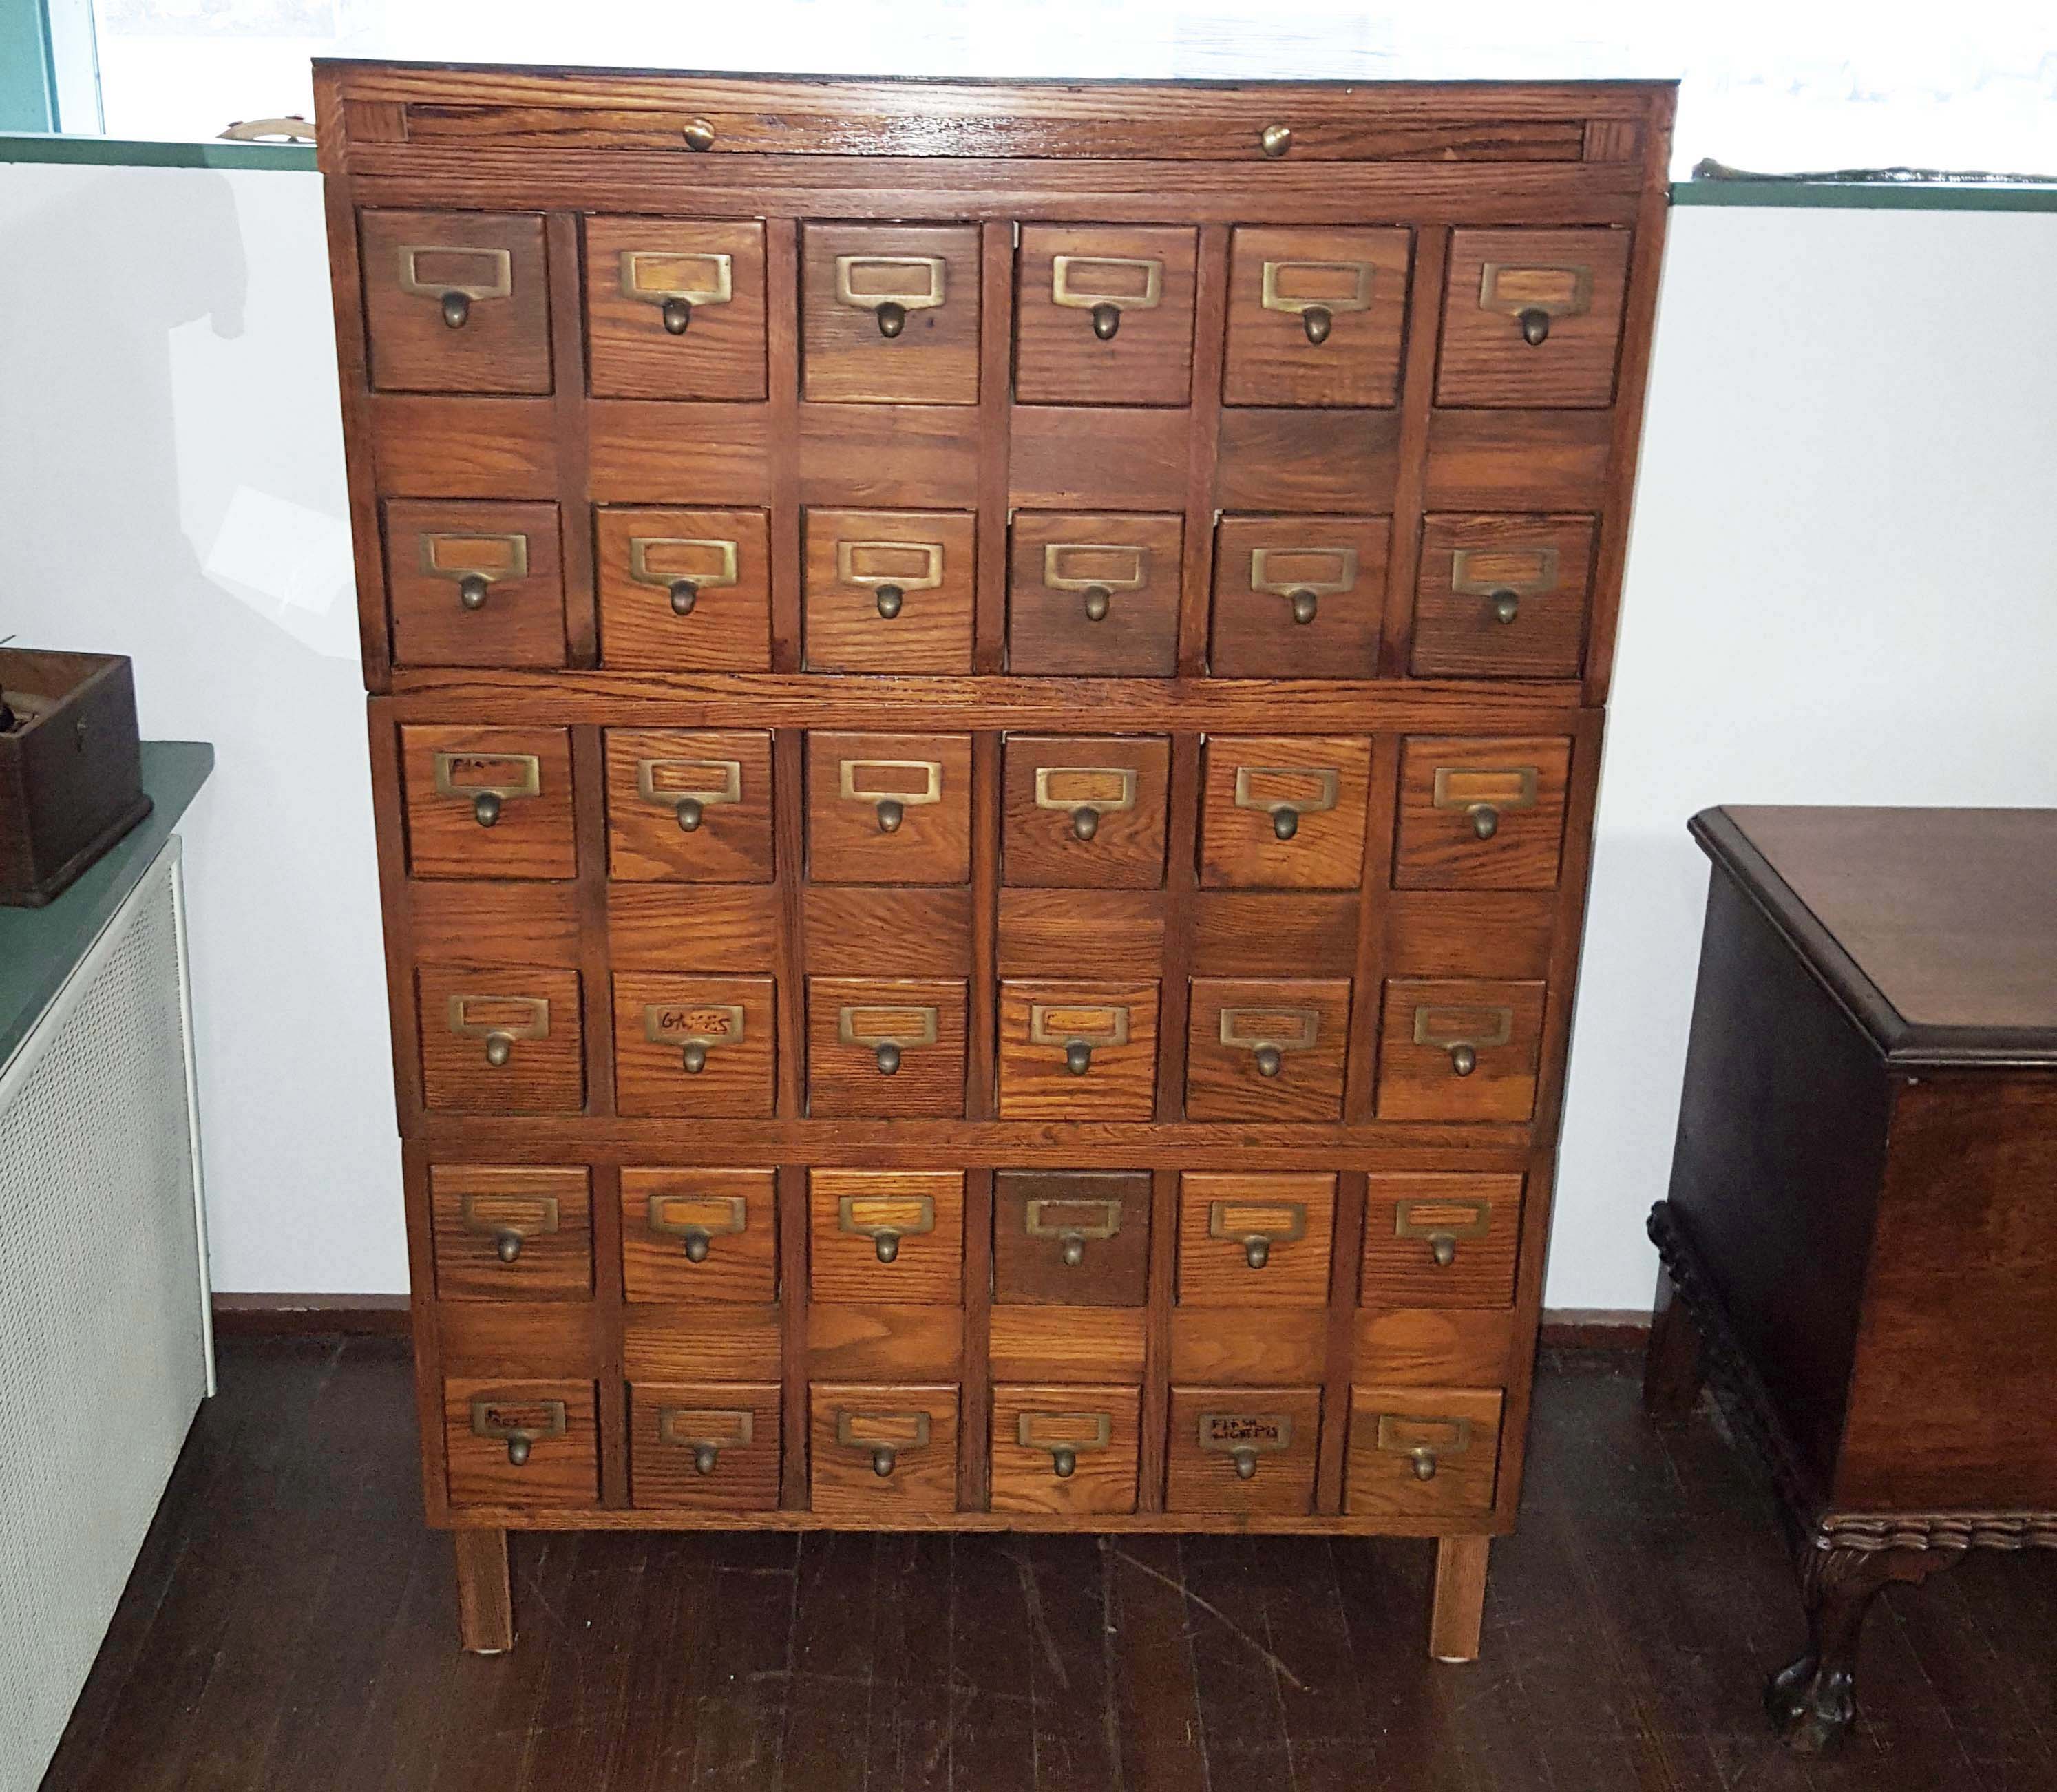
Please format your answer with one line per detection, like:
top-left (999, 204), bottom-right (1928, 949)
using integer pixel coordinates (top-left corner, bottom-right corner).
top-left (385, 498), bottom-right (564, 666)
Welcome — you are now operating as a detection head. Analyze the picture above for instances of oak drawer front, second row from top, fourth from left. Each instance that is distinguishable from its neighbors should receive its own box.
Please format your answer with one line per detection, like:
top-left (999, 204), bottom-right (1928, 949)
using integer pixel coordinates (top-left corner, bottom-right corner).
top-left (1008, 510), bottom-right (1185, 677)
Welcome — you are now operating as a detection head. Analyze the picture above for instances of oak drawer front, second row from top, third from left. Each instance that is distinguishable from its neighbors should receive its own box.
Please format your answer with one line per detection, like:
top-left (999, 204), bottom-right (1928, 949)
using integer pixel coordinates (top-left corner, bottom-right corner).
top-left (806, 510), bottom-right (977, 673)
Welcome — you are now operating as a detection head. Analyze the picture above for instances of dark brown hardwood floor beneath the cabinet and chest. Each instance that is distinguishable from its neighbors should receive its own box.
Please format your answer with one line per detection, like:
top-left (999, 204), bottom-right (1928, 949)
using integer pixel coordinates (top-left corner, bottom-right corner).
top-left (45, 1340), bottom-right (2057, 1792)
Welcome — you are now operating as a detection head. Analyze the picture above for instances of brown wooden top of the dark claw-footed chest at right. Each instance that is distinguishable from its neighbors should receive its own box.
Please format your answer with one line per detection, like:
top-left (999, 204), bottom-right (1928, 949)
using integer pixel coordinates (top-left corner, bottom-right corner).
top-left (1693, 808), bottom-right (2057, 1066)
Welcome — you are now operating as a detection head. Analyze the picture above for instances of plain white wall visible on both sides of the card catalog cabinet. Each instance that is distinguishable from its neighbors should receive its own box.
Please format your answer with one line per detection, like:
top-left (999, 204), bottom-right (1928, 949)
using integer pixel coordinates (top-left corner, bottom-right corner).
top-left (0, 167), bottom-right (2057, 1307)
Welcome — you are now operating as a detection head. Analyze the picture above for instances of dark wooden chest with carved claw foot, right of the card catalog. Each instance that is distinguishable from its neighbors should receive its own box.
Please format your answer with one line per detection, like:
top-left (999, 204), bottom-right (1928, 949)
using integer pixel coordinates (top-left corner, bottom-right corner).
top-left (1643, 808), bottom-right (2057, 1751)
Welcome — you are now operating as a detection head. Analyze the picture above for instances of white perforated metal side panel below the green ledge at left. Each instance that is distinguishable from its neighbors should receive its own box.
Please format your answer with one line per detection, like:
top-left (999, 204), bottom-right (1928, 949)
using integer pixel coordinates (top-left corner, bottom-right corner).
top-left (0, 839), bottom-right (210, 1792)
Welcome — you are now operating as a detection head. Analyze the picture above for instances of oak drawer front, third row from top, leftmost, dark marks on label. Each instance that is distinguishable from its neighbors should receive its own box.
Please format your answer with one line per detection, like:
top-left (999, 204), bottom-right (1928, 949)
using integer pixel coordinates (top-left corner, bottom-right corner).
top-left (399, 724), bottom-right (578, 878)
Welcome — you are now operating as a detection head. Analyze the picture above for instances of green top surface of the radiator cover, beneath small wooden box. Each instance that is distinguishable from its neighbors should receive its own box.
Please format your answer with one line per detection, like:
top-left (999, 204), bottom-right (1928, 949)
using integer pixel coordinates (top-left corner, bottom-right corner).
top-left (0, 741), bottom-right (214, 1066)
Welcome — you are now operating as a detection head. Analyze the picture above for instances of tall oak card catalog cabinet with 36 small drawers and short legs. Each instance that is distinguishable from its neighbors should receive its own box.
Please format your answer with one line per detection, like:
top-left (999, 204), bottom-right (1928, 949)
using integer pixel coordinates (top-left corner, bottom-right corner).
top-left (319, 62), bottom-right (1672, 1658)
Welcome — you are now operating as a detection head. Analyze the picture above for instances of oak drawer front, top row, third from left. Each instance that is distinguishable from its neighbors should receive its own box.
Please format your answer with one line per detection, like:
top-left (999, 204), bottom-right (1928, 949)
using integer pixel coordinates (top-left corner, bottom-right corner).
top-left (800, 224), bottom-right (979, 405)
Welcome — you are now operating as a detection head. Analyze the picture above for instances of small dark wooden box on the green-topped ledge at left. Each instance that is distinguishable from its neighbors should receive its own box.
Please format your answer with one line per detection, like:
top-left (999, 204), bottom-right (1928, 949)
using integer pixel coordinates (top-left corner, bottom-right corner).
top-left (0, 648), bottom-right (150, 909)
